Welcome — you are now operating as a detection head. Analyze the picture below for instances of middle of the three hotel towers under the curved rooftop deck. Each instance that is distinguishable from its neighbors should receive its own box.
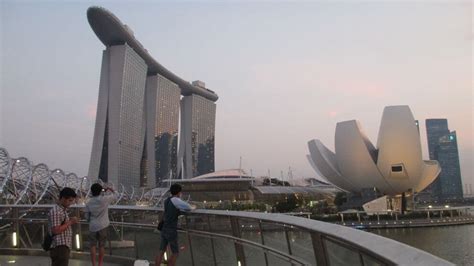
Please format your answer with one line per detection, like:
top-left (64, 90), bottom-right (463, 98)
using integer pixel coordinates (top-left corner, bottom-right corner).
top-left (144, 75), bottom-right (181, 187)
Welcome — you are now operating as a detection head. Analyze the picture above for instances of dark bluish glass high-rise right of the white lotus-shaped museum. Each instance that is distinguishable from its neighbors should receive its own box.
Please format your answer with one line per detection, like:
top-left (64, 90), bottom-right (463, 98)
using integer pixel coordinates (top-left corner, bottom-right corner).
top-left (426, 119), bottom-right (463, 200)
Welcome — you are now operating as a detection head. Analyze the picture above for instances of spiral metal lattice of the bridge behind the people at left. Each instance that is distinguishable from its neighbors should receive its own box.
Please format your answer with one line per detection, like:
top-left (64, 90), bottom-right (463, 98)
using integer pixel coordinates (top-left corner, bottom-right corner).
top-left (0, 147), bottom-right (166, 206)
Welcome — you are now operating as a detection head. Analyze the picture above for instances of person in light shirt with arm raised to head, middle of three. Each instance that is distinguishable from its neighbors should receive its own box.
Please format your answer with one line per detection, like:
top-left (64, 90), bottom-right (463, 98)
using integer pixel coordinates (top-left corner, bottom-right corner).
top-left (86, 183), bottom-right (117, 266)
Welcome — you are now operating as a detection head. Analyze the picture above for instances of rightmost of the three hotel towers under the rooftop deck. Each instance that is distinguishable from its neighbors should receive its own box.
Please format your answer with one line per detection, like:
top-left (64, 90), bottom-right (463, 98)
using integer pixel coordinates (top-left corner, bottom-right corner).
top-left (178, 90), bottom-right (216, 179)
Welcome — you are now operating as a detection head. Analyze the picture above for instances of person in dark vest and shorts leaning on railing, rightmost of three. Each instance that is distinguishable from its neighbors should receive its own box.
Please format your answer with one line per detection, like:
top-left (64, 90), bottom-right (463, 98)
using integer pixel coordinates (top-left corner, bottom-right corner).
top-left (155, 184), bottom-right (194, 266)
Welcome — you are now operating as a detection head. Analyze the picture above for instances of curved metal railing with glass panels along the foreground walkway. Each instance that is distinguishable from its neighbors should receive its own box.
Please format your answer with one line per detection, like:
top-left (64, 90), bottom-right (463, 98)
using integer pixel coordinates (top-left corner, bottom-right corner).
top-left (0, 205), bottom-right (452, 265)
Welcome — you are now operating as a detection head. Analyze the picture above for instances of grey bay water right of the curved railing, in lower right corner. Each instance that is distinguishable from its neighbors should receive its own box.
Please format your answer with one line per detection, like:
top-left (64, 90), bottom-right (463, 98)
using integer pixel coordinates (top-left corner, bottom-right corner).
top-left (370, 224), bottom-right (474, 265)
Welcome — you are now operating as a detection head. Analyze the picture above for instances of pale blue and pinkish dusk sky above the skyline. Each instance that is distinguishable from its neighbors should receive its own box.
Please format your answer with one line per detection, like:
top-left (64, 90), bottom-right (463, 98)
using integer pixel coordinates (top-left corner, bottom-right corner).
top-left (0, 0), bottom-right (474, 191)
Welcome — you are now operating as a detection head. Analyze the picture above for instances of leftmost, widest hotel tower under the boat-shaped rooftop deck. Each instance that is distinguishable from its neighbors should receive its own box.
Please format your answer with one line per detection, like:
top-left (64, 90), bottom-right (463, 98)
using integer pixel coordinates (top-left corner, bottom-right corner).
top-left (89, 44), bottom-right (147, 187)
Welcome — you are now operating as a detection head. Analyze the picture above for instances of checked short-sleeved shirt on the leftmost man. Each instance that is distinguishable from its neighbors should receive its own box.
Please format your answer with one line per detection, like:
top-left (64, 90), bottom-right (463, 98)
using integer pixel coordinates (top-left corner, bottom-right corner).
top-left (48, 205), bottom-right (72, 248)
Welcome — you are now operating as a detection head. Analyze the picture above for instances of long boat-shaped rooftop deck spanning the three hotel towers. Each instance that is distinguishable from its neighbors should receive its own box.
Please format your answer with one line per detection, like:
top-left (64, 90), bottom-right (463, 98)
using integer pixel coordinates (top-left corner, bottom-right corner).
top-left (87, 6), bottom-right (219, 102)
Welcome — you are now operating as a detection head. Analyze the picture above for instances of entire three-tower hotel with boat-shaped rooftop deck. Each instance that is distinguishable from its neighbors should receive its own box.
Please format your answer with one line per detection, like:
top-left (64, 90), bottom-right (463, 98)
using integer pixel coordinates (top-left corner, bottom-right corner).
top-left (87, 7), bottom-right (218, 187)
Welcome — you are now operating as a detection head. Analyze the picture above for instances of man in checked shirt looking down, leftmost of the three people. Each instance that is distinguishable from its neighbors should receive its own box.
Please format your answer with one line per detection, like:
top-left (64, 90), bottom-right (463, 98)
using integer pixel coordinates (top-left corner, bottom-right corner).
top-left (48, 187), bottom-right (79, 266)
